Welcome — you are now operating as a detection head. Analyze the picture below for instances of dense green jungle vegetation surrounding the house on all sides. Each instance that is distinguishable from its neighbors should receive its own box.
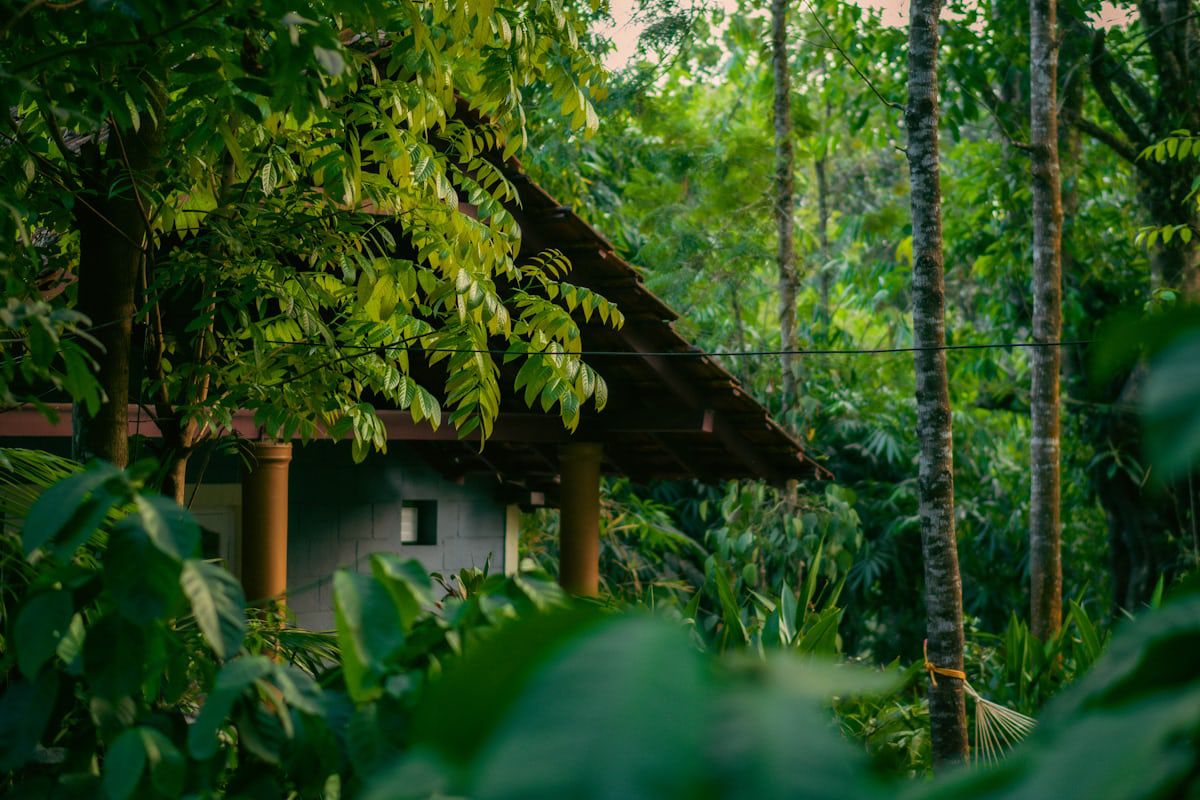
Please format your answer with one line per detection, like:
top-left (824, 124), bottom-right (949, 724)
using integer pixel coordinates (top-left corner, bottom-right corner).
top-left (0, 0), bottom-right (1200, 800)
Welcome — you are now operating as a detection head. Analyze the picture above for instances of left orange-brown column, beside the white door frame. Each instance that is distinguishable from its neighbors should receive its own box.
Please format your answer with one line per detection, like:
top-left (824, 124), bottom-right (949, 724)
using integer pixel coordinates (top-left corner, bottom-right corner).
top-left (241, 441), bottom-right (292, 603)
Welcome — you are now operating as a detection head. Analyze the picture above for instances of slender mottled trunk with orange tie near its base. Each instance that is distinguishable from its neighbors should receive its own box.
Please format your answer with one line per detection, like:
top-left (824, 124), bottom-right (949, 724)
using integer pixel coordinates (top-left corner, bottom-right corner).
top-left (905, 0), bottom-right (967, 765)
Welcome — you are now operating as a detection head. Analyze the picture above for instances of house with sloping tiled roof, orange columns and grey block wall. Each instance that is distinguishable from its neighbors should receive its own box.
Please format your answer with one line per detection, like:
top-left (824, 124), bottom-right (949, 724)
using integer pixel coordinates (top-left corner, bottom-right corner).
top-left (0, 155), bottom-right (823, 628)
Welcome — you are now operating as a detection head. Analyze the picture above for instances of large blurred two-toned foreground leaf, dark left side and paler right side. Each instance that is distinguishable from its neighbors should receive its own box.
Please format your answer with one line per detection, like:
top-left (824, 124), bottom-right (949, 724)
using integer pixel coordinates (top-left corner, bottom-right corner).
top-left (367, 609), bottom-right (707, 799)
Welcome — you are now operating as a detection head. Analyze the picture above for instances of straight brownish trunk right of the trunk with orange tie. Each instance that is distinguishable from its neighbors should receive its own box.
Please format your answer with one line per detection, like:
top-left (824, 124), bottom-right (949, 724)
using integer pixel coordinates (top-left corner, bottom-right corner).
top-left (1030, 0), bottom-right (1062, 642)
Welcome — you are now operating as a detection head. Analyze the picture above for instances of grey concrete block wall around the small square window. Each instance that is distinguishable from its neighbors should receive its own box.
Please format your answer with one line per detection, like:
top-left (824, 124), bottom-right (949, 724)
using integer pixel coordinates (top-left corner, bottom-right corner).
top-left (288, 441), bottom-right (510, 630)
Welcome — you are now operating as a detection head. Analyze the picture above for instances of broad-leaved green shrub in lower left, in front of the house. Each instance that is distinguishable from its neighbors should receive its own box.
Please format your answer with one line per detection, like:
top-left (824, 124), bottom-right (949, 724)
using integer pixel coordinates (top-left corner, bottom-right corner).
top-left (0, 450), bottom-right (563, 800)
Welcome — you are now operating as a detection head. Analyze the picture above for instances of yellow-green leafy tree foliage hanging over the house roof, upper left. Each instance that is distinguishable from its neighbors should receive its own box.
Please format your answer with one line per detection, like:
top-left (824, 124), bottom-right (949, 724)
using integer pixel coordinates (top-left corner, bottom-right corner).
top-left (0, 0), bottom-right (622, 457)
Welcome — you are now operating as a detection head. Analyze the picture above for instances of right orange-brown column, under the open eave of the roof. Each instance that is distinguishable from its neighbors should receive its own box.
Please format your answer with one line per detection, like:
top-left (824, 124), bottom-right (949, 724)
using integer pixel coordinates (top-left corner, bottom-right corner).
top-left (558, 441), bottom-right (604, 597)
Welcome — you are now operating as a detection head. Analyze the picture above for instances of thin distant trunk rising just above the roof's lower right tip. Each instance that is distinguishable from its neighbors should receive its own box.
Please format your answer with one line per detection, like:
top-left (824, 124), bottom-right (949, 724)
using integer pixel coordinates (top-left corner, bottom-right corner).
top-left (770, 0), bottom-right (797, 408)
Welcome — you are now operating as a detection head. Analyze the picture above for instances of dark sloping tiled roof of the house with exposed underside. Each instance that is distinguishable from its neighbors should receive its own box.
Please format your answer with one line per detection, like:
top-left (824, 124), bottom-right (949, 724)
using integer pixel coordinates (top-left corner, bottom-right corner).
top-left (403, 160), bottom-right (828, 492)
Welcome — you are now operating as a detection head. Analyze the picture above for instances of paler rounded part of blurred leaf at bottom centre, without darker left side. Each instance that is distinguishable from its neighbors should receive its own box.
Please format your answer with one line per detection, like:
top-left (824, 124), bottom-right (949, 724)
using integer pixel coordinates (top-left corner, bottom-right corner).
top-left (472, 616), bottom-right (712, 800)
